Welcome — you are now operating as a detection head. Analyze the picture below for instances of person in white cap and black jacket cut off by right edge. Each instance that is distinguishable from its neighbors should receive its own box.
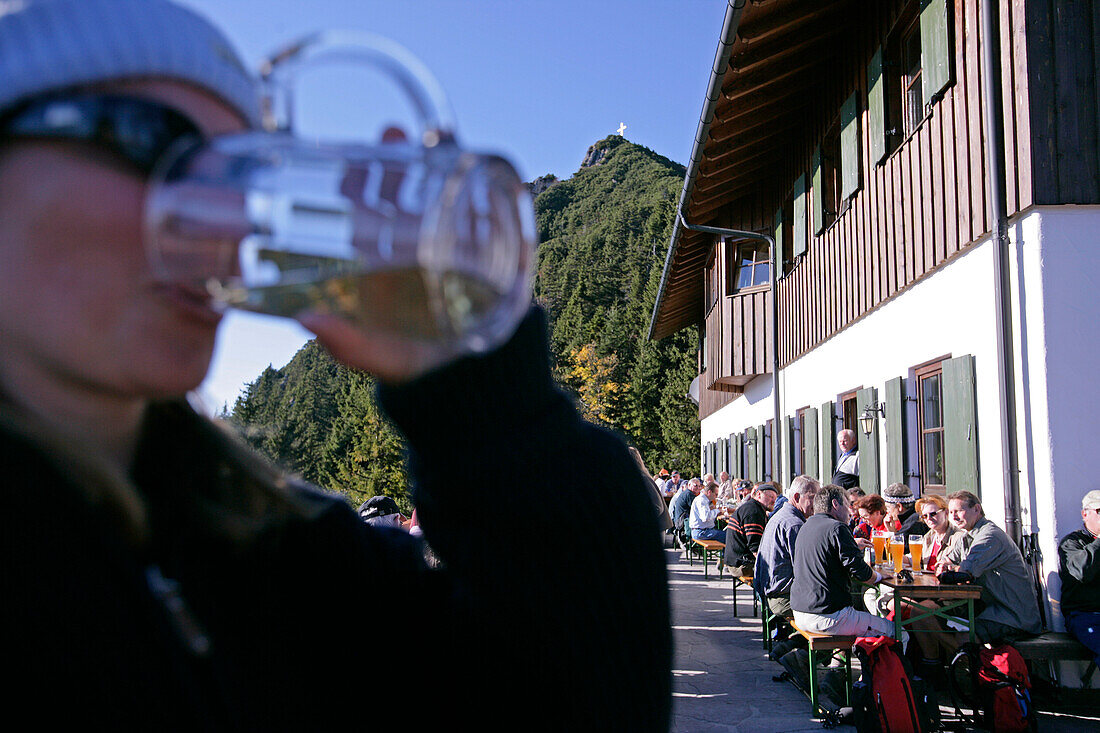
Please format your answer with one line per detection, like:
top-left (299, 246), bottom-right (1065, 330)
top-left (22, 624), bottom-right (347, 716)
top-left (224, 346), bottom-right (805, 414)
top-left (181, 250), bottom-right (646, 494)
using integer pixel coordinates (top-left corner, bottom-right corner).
top-left (1058, 489), bottom-right (1100, 665)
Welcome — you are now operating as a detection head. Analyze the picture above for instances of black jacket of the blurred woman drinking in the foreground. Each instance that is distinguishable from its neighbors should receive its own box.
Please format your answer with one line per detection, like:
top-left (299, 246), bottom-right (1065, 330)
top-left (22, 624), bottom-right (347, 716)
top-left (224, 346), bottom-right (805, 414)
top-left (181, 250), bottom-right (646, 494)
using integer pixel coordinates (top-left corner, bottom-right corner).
top-left (0, 315), bottom-right (671, 731)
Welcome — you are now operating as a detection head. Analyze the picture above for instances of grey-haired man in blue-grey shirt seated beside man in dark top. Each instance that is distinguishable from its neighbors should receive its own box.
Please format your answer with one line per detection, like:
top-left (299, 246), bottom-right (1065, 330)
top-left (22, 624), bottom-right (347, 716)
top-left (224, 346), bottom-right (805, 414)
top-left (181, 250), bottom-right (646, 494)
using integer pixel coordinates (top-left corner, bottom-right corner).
top-left (752, 475), bottom-right (821, 619)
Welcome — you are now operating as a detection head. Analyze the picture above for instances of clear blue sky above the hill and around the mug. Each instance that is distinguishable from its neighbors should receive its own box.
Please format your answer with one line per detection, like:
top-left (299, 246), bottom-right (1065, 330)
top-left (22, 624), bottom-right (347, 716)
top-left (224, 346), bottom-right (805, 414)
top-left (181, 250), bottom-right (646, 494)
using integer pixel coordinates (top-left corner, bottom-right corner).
top-left (178, 0), bottom-right (726, 409)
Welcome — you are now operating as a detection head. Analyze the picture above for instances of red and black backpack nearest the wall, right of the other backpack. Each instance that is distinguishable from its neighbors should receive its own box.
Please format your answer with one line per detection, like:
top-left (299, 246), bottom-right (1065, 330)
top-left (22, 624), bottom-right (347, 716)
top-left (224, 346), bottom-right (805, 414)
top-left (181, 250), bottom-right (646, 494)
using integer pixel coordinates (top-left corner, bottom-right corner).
top-left (948, 644), bottom-right (1036, 733)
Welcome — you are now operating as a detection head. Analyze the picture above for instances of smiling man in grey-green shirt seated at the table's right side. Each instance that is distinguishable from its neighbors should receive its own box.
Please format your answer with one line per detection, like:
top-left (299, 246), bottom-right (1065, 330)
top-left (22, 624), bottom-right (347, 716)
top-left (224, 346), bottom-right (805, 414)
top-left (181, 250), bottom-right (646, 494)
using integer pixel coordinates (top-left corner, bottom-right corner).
top-left (936, 491), bottom-right (1043, 644)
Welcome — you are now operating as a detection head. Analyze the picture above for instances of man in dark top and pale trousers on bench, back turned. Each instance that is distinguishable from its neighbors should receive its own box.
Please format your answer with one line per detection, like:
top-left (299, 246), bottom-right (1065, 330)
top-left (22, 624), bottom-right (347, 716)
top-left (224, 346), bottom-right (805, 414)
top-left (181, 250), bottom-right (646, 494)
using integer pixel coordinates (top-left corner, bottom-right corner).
top-left (791, 484), bottom-right (893, 636)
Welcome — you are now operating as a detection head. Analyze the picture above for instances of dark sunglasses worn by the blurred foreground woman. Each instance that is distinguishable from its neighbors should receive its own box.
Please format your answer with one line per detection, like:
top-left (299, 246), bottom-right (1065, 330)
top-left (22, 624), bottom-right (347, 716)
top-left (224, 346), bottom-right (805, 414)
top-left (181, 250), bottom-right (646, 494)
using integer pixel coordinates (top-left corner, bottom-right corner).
top-left (0, 94), bottom-right (202, 177)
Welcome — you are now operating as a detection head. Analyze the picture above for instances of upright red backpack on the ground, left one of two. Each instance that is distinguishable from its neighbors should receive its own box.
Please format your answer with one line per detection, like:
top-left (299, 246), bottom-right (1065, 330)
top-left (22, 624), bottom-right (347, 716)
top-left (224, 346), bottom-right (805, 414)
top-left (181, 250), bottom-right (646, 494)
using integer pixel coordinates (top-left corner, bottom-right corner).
top-left (853, 636), bottom-right (931, 733)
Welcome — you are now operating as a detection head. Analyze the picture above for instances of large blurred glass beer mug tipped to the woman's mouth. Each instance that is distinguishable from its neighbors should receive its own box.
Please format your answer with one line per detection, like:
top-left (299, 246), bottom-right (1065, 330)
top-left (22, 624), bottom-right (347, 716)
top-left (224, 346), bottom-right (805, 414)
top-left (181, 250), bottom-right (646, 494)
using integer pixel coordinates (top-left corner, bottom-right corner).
top-left (145, 32), bottom-right (535, 369)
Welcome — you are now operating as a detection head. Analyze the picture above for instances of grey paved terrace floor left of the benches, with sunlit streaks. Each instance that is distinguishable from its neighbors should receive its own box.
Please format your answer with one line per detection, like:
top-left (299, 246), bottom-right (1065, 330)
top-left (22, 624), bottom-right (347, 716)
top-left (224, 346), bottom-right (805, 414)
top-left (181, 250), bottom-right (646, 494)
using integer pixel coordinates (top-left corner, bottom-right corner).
top-left (666, 550), bottom-right (1100, 733)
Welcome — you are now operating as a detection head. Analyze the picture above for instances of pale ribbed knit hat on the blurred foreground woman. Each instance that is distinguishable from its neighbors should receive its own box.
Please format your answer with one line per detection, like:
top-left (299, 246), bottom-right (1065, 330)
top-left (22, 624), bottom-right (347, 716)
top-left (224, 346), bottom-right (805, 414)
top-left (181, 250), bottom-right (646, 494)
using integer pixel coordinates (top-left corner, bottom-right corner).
top-left (0, 0), bottom-right (260, 127)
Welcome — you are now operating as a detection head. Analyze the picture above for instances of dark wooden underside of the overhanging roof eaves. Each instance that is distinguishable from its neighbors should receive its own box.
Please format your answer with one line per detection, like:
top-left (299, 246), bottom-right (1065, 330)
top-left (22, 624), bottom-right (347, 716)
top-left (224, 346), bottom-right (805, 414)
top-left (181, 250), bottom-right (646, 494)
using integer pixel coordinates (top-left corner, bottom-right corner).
top-left (649, 0), bottom-right (870, 339)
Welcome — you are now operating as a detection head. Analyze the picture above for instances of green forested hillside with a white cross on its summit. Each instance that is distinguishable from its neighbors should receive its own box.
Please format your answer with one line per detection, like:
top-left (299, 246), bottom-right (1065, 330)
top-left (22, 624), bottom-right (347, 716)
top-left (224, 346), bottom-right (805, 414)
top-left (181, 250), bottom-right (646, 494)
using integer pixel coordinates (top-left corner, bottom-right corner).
top-left (228, 135), bottom-right (699, 508)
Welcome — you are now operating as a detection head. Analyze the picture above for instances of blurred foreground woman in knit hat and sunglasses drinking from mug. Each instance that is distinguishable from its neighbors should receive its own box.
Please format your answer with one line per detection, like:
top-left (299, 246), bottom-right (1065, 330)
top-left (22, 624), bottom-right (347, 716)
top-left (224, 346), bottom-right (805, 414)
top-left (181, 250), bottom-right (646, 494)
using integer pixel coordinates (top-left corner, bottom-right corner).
top-left (0, 0), bottom-right (671, 730)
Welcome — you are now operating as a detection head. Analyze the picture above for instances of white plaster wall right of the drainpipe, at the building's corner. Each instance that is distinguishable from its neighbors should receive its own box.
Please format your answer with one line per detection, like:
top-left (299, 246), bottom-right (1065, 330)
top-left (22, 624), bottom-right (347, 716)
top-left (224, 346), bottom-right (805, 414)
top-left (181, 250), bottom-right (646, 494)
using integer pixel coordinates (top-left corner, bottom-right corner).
top-left (1013, 206), bottom-right (1100, 628)
